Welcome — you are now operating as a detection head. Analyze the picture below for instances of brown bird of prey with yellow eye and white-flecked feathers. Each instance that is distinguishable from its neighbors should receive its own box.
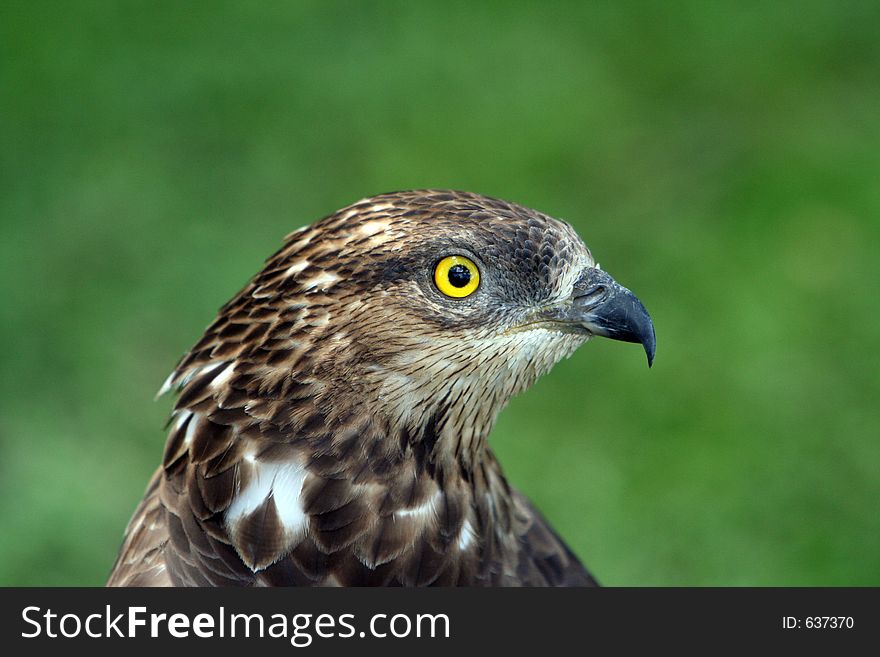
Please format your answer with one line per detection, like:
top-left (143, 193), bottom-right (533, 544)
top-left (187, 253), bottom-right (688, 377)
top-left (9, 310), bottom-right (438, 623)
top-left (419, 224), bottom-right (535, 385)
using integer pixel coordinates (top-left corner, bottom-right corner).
top-left (108, 190), bottom-right (655, 586)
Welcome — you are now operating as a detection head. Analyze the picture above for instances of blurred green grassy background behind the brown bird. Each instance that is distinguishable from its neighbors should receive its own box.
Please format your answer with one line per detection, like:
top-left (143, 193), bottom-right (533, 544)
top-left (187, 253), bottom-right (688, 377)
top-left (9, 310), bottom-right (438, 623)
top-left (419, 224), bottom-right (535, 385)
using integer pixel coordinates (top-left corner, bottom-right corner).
top-left (0, 0), bottom-right (880, 585)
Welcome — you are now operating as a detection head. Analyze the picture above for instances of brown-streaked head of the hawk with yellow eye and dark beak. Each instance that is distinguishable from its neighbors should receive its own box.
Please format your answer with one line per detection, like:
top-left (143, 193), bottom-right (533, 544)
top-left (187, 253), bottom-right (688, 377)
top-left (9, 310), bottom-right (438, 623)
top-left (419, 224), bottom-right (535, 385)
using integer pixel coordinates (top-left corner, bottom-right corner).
top-left (172, 190), bottom-right (655, 472)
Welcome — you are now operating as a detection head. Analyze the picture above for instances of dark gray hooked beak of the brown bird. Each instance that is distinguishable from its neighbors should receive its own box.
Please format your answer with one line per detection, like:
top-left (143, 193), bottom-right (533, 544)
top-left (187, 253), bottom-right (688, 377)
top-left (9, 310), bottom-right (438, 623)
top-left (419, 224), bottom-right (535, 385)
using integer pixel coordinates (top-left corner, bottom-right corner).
top-left (568, 267), bottom-right (657, 367)
